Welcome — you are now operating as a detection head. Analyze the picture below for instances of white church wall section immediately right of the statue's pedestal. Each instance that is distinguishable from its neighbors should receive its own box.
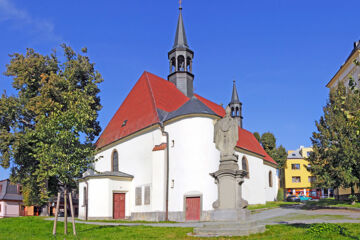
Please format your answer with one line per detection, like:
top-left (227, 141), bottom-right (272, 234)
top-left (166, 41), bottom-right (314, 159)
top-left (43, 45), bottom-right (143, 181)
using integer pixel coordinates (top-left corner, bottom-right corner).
top-left (236, 152), bottom-right (266, 204)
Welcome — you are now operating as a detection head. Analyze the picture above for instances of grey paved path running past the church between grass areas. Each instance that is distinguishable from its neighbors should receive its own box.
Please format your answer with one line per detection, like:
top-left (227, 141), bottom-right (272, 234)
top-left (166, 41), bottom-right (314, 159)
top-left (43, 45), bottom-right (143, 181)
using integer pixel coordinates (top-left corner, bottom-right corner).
top-left (46, 207), bottom-right (360, 227)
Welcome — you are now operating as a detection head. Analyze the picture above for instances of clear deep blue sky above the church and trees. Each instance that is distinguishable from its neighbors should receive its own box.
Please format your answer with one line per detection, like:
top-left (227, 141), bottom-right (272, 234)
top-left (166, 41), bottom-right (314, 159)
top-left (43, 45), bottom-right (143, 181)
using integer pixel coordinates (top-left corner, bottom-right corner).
top-left (0, 0), bottom-right (360, 179)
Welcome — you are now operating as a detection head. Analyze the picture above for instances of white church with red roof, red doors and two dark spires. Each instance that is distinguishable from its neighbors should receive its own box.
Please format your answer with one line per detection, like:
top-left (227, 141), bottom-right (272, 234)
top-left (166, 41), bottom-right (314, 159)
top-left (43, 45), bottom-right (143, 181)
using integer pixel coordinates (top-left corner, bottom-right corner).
top-left (79, 5), bottom-right (279, 221)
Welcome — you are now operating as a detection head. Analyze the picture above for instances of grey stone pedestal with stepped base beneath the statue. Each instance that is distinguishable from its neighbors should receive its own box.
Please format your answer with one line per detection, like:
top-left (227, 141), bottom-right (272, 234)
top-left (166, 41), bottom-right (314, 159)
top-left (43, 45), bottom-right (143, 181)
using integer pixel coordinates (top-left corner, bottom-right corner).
top-left (191, 155), bottom-right (265, 237)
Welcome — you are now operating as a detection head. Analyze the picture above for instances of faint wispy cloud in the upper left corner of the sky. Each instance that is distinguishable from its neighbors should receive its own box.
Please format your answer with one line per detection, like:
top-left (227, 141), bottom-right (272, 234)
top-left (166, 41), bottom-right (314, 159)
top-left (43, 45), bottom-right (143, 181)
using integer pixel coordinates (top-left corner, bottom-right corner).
top-left (0, 0), bottom-right (61, 42)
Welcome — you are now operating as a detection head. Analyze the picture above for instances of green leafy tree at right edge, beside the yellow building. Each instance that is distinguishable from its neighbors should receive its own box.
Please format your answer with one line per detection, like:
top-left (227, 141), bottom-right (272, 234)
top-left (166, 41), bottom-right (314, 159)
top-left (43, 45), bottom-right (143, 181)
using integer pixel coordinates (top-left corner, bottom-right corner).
top-left (309, 83), bottom-right (360, 199)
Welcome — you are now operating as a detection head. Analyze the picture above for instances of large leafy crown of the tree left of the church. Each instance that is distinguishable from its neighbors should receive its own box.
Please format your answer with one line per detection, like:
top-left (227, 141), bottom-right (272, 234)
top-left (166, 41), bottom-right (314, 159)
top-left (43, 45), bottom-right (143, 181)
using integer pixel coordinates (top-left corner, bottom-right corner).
top-left (0, 45), bottom-right (103, 205)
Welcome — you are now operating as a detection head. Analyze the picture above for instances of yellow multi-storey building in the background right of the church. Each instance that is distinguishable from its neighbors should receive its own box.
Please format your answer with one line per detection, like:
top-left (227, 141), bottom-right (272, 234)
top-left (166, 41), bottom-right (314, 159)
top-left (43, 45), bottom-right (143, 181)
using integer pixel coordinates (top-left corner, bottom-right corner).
top-left (285, 146), bottom-right (333, 198)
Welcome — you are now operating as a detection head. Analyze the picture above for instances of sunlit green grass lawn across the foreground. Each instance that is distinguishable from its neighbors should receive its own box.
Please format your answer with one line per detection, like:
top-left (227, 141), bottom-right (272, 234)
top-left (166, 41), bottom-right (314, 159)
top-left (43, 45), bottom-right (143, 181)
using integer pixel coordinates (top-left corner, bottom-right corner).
top-left (0, 217), bottom-right (360, 240)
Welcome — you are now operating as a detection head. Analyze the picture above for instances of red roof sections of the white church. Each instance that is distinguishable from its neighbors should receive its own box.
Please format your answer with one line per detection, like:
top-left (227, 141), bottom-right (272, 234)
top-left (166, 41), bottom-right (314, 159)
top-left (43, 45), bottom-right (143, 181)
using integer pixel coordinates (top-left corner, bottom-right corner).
top-left (96, 72), bottom-right (276, 164)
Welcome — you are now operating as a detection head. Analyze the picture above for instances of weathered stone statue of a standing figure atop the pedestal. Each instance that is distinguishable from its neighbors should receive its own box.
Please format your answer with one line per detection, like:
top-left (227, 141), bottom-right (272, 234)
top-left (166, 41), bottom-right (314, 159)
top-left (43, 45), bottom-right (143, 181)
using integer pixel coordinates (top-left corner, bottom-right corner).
top-left (214, 106), bottom-right (239, 159)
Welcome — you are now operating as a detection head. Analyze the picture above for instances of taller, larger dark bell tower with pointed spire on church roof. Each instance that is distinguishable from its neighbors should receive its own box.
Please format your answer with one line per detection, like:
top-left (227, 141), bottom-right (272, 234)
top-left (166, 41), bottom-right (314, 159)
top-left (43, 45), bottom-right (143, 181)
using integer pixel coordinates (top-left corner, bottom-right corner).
top-left (168, 5), bottom-right (194, 98)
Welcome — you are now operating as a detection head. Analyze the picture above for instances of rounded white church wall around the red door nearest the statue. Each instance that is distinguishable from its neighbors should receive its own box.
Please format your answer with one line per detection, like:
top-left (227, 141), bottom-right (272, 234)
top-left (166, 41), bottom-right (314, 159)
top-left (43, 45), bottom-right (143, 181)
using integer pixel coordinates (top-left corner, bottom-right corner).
top-left (165, 117), bottom-right (220, 212)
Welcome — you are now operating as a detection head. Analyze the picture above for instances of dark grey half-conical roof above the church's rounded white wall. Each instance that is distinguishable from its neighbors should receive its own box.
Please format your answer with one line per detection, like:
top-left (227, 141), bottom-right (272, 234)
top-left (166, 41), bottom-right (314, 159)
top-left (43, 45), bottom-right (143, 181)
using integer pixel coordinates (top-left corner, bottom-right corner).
top-left (158, 96), bottom-right (217, 122)
